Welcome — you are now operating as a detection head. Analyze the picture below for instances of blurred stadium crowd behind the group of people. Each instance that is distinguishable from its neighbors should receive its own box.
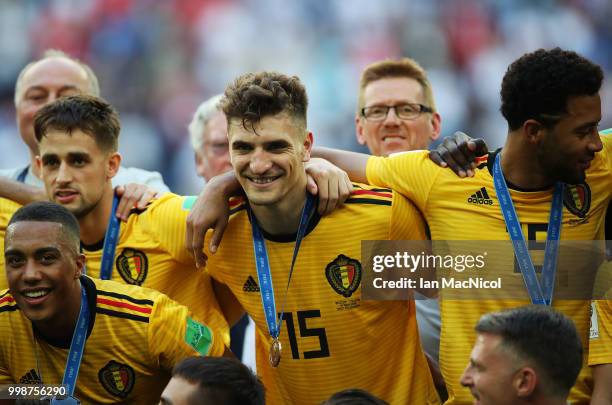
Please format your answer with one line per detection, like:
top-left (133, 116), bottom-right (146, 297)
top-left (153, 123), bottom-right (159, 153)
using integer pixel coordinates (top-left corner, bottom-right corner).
top-left (0, 0), bottom-right (612, 194)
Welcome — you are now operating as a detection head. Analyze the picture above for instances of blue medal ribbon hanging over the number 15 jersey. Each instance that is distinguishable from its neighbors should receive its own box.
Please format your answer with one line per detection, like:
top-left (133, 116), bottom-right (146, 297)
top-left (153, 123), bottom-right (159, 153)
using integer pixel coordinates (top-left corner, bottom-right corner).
top-left (248, 193), bottom-right (315, 348)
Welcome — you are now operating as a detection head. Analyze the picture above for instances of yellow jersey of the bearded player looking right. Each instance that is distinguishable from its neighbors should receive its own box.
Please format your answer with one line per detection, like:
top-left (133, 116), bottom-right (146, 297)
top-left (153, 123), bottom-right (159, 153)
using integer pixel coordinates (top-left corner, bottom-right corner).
top-left (367, 135), bottom-right (612, 404)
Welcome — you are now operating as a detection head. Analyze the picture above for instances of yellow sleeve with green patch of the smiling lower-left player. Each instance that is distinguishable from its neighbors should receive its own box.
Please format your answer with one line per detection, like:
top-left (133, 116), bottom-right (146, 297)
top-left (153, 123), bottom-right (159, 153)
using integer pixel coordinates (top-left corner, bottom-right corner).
top-left (148, 293), bottom-right (228, 370)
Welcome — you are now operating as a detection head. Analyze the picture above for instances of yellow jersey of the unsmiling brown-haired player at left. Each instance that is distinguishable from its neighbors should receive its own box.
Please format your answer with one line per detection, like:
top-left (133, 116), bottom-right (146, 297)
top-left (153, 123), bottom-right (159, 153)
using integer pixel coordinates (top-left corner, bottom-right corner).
top-left (83, 194), bottom-right (229, 346)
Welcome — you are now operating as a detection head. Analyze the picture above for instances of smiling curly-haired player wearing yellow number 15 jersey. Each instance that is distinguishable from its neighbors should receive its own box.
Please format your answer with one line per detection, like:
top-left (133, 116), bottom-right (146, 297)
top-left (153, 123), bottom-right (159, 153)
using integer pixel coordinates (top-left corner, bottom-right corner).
top-left (197, 72), bottom-right (439, 405)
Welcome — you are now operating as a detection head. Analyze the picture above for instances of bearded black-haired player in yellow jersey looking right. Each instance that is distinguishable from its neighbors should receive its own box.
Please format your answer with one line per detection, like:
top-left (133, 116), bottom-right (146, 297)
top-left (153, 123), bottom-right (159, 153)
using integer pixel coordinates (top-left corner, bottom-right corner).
top-left (319, 48), bottom-right (612, 404)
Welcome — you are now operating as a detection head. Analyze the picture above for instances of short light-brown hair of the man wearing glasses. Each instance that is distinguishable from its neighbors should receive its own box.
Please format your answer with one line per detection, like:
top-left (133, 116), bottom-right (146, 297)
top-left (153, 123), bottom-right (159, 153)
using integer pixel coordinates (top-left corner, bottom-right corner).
top-left (357, 58), bottom-right (436, 111)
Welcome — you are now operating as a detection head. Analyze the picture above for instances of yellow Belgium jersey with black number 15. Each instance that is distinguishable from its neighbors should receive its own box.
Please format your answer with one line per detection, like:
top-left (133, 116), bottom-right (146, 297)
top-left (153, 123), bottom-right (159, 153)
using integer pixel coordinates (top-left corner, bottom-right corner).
top-left (207, 185), bottom-right (439, 405)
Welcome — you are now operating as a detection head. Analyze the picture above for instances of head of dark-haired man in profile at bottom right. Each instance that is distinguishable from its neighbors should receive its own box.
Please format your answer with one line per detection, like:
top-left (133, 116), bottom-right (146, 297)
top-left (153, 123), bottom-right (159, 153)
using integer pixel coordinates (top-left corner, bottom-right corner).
top-left (461, 306), bottom-right (583, 405)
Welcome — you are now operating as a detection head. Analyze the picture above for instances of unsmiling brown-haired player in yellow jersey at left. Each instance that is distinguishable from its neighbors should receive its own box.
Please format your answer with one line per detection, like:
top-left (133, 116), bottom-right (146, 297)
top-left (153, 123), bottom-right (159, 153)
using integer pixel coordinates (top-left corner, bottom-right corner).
top-left (15, 95), bottom-right (229, 340)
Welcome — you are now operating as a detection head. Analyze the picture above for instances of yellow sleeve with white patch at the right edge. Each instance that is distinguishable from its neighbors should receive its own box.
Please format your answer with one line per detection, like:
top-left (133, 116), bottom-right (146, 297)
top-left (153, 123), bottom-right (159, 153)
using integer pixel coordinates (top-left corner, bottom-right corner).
top-left (589, 300), bottom-right (612, 366)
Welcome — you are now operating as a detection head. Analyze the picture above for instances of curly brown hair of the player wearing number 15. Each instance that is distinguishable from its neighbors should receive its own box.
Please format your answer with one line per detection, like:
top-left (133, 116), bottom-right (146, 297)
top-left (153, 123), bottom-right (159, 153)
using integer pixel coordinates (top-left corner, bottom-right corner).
top-left (221, 72), bottom-right (308, 129)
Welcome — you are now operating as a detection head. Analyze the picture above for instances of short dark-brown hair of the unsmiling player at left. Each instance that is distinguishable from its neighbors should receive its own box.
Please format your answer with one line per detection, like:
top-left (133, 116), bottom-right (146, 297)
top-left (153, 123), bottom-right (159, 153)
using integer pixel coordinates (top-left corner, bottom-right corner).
top-left (34, 95), bottom-right (121, 152)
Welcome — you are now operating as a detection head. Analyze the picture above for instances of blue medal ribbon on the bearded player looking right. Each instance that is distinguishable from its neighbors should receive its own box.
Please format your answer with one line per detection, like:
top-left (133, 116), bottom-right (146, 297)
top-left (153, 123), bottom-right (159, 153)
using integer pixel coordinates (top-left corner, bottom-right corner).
top-left (493, 153), bottom-right (564, 306)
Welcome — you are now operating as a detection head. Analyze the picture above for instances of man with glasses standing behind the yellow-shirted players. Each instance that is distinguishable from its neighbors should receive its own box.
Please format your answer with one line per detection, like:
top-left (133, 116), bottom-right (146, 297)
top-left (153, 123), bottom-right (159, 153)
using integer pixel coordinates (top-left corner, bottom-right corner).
top-left (355, 58), bottom-right (444, 382)
